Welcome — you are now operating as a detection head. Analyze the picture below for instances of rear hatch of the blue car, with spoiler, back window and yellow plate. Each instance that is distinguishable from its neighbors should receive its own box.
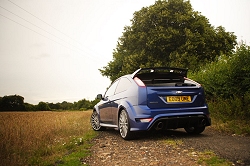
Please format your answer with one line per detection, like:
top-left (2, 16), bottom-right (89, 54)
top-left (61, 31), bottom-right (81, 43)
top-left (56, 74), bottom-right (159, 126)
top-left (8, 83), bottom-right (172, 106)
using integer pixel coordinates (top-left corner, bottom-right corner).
top-left (133, 67), bottom-right (205, 108)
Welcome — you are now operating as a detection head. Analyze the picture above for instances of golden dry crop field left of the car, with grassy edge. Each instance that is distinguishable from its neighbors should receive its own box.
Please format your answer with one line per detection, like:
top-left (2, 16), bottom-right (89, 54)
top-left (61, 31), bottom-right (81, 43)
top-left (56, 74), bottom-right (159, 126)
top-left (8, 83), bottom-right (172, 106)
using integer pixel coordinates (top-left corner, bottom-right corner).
top-left (0, 111), bottom-right (95, 165)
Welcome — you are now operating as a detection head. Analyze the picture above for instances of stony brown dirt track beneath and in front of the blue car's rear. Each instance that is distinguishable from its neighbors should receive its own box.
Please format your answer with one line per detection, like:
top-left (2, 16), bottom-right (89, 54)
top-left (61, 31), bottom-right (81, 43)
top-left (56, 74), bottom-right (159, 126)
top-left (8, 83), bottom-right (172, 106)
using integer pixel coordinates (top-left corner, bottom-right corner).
top-left (83, 128), bottom-right (250, 166)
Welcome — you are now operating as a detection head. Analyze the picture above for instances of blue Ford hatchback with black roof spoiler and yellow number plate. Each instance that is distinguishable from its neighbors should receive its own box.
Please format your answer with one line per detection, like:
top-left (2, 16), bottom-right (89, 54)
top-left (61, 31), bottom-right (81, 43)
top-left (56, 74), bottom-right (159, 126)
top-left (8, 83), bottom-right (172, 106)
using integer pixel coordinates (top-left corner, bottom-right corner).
top-left (90, 67), bottom-right (211, 140)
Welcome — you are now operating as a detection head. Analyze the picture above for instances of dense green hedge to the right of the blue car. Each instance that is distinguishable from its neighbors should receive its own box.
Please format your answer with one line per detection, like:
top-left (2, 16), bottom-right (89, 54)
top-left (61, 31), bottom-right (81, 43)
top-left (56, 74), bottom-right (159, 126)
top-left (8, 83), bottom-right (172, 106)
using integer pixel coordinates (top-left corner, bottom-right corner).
top-left (189, 45), bottom-right (250, 121)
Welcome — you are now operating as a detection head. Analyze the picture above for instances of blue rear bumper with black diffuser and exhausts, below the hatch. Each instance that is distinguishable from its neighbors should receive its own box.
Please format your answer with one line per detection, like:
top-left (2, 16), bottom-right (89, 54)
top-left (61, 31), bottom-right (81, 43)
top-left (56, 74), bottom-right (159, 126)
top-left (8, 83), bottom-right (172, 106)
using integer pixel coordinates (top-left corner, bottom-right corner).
top-left (128, 105), bottom-right (211, 131)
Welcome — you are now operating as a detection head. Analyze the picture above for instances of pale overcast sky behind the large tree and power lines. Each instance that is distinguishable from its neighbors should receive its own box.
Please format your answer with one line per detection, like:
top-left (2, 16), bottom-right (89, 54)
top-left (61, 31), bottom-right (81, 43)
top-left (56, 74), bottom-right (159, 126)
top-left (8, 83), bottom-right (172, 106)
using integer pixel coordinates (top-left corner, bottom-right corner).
top-left (0, 0), bottom-right (250, 104)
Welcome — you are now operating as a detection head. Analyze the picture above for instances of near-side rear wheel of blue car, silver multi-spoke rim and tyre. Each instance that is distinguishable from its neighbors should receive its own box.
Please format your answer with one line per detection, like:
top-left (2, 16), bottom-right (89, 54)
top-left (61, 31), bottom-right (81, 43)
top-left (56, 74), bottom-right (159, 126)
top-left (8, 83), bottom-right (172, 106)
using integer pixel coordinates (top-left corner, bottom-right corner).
top-left (118, 110), bottom-right (133, 140)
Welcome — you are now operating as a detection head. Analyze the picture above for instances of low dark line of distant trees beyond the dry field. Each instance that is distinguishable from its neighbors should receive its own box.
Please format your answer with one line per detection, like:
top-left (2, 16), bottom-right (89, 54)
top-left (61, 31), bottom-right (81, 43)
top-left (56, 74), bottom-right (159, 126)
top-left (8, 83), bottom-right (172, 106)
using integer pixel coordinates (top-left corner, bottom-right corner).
top-left (0, 95), bottom-right (99, 112)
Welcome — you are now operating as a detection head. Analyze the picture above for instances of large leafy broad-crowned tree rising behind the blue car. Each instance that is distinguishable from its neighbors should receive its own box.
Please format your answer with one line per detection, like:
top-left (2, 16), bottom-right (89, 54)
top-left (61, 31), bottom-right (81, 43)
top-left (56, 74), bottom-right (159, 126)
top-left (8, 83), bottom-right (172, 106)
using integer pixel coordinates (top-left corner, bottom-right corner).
top-left (99, 0), bottom-right (236, 81)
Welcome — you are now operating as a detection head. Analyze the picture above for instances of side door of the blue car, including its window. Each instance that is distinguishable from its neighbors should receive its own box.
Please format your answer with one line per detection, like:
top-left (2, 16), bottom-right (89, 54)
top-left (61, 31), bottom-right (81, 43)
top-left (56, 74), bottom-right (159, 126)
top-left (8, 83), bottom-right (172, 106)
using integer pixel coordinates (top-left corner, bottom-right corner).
top-left (99, 80), bottom-right (119, 124)
